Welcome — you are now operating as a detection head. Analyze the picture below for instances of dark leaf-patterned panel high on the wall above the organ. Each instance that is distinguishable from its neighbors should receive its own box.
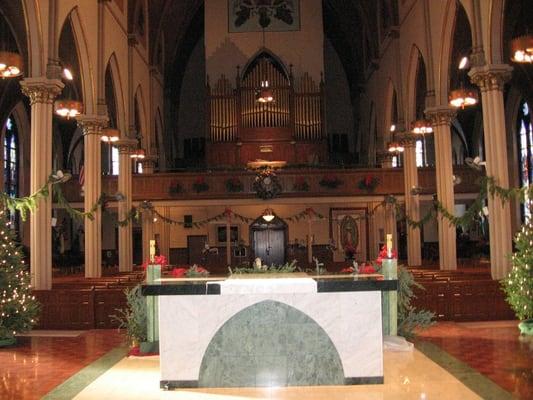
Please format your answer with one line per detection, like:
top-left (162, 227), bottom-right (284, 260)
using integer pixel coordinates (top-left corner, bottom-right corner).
top-left (228, 0), bottom-right (300, 33)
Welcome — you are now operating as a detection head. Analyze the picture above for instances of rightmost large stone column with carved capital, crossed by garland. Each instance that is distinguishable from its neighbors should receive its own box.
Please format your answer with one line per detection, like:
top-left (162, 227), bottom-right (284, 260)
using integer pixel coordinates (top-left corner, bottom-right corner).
top-left (469, 65), bottom-right (513, 279)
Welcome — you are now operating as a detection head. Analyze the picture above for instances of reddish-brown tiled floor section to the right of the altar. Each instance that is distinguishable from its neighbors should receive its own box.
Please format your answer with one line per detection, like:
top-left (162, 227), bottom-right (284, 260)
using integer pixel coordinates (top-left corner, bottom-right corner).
top-left (420, 321), bottom-right (533, 399)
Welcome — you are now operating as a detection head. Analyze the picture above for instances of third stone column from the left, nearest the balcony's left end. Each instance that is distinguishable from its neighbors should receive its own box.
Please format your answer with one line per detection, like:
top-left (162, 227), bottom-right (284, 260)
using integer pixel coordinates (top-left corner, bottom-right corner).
top-left (115, 138), bottom-right (137, 272)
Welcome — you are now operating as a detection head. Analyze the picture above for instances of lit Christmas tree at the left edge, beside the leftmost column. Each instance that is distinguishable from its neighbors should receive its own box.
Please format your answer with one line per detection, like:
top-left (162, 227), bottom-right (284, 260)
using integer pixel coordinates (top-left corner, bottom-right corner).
top-left (0, 209), bottom-right (39, 347)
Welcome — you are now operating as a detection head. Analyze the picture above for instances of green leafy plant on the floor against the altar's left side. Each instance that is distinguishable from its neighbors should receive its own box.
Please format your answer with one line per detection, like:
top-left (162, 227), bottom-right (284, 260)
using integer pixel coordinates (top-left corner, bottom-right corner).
top-left (110, 284), bottom-right (148, 347)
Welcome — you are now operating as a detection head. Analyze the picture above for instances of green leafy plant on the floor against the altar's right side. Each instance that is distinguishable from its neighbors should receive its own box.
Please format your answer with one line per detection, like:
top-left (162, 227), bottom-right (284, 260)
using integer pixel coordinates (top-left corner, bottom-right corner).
top-left (398, 265), bottom-right (435, 339)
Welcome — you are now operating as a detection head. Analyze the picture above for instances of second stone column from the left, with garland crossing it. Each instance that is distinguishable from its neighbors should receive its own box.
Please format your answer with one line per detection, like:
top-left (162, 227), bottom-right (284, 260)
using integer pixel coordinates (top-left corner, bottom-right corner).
top-left (77, 115), bottom-right (107, 278)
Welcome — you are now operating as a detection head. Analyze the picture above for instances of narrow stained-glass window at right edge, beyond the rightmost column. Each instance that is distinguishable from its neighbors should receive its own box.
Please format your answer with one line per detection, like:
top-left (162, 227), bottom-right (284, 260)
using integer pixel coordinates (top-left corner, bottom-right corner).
top-left (517, 101), bottom-right (533, 220)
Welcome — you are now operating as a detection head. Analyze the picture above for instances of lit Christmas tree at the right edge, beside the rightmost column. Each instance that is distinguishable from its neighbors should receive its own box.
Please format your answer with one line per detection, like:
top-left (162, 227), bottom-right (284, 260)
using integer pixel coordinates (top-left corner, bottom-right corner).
top-left (502, 218), bottom-right (533, 331)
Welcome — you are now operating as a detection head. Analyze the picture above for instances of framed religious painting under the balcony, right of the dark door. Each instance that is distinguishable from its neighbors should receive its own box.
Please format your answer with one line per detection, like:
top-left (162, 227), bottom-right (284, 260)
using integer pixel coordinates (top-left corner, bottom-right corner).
top-left (330, 208), bottom-right (368, 262)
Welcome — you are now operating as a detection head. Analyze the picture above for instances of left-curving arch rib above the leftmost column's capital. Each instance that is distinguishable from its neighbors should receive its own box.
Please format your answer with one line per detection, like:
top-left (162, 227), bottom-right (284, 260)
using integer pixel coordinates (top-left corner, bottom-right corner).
top-left (22, 0), bottom-right (46, 77)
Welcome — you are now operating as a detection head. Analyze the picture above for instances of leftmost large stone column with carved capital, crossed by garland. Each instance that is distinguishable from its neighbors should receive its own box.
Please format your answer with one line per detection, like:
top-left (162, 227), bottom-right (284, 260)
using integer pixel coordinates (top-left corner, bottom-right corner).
top-left (20, 77), bottom-right (63, 290)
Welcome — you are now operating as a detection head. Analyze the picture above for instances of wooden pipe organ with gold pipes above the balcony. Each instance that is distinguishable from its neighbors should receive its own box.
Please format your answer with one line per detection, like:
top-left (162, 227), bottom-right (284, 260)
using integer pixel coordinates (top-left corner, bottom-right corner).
top-left (206, 53), bottom-right (327, 165)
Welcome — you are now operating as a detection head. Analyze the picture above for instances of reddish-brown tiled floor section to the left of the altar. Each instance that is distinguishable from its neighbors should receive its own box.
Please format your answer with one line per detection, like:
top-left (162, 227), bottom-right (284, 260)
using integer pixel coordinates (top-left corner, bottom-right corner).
top-left (0, 330), bottom-right (123, 400)
